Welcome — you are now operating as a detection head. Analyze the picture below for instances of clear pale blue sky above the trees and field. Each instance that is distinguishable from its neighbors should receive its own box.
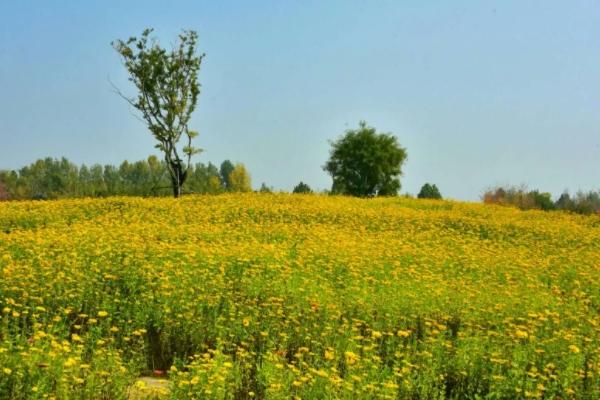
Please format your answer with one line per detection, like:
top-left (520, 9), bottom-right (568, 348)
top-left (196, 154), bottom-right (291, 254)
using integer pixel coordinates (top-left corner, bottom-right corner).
top-left (0, 0), bottom-right (600, 200)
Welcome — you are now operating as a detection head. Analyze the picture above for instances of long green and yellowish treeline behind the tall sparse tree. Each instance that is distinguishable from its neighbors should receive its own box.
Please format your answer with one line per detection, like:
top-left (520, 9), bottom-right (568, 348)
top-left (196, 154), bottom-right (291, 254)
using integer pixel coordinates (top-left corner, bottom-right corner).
top-left (0, 156), bottom-right (252, 200)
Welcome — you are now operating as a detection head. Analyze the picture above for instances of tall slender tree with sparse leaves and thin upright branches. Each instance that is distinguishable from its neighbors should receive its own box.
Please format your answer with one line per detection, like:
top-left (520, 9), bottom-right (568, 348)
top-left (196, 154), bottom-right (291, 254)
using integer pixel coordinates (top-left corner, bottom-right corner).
top-left (111, 29), bottom-right (204, 197)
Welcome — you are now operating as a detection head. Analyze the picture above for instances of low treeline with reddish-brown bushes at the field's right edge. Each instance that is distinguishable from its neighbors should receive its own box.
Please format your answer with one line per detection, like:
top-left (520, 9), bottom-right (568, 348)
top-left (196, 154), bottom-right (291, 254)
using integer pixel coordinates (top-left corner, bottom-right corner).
top-left (482, 187), bottom-right (600, 214)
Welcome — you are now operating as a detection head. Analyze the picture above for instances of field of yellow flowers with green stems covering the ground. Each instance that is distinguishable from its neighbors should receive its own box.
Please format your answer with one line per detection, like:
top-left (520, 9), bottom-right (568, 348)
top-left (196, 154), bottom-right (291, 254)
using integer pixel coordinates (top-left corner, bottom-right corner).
top-left (0, 194), bottom-right (600, 399)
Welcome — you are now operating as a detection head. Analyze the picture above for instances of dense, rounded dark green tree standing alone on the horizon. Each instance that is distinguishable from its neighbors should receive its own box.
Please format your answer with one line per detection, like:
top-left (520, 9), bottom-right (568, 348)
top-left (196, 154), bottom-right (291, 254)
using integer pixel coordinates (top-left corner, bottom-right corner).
top-left (323, 121), bottom-right (407, 196)
